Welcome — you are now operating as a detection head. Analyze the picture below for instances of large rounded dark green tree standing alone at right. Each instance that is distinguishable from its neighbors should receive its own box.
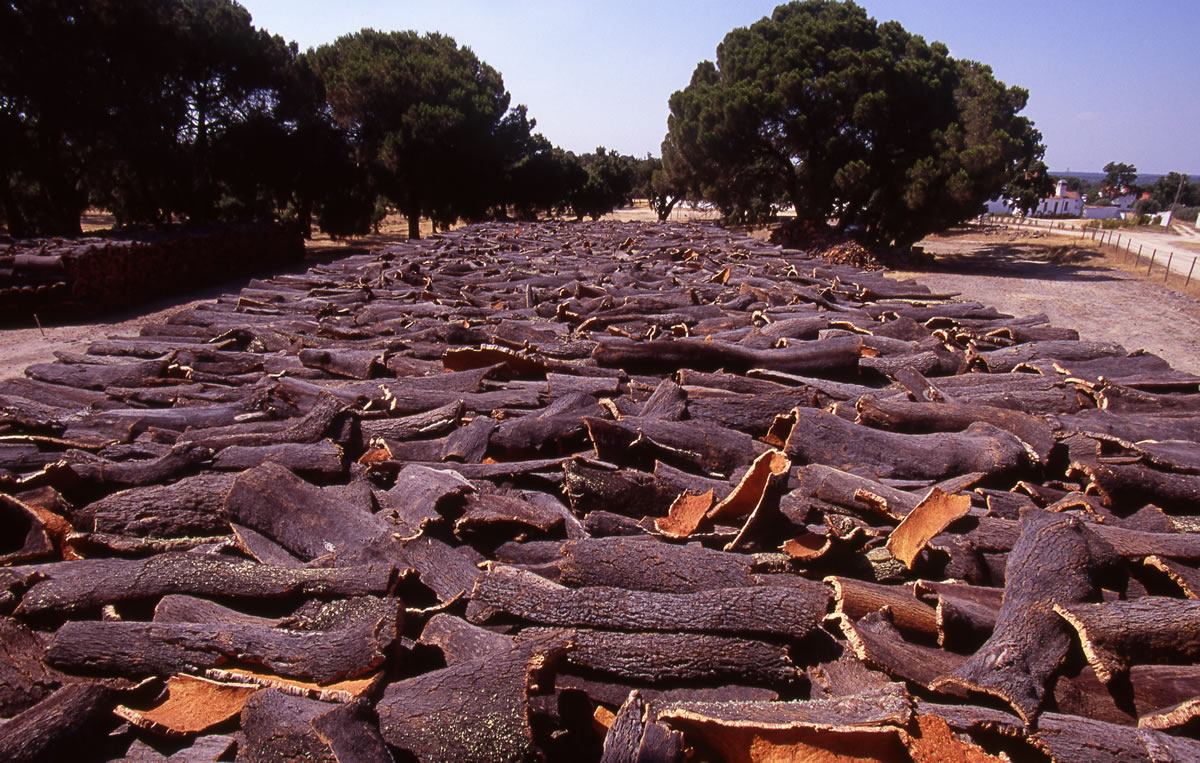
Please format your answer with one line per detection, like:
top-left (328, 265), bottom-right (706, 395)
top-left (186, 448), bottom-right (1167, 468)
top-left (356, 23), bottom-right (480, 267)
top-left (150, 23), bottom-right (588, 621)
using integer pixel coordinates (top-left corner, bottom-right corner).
top-left (654, 0), bottom-right (1052, 245)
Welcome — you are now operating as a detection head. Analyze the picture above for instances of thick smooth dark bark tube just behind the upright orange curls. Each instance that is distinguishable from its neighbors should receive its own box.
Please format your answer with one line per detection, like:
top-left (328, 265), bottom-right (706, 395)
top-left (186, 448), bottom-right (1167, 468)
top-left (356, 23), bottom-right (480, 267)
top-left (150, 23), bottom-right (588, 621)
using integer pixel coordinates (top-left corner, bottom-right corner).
top-left (784, 408), bottom-right (1025, 480)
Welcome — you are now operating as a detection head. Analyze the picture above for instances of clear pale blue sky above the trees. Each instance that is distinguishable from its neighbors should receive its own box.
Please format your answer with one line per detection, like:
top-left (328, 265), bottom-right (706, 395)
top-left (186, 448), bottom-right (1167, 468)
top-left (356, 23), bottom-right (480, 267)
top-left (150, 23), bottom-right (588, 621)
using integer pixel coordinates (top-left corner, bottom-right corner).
top-left (240, 0), bottom-right (1200, 175)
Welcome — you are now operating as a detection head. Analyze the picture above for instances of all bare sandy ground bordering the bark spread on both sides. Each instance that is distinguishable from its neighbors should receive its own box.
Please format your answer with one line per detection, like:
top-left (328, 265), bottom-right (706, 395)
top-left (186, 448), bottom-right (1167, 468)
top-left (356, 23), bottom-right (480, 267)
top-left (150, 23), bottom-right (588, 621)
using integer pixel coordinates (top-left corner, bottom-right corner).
top-left (0, 213), bottom-right (1200, 378)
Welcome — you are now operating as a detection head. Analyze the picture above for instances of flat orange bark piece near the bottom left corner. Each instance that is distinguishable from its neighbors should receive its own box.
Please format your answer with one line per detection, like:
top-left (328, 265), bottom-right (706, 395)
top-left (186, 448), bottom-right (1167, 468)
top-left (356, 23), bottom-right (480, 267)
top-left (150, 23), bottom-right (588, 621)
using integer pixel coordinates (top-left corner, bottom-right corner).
top-left (115, 675), bottom-right (262, 737)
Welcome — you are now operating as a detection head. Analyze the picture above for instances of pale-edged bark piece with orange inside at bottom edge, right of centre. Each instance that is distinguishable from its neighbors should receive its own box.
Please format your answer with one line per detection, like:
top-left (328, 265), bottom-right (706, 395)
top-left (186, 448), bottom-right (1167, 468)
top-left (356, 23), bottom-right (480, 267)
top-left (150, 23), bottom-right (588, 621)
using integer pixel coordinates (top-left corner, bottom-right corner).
top-left (649, 684), bottom-right (912, 762)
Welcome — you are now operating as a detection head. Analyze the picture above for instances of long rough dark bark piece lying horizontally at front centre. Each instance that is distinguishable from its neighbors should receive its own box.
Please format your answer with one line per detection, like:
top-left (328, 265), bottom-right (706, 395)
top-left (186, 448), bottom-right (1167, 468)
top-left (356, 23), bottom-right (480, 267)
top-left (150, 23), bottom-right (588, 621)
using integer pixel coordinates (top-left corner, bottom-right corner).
top-left (467, 566), bottom-right (829, 638)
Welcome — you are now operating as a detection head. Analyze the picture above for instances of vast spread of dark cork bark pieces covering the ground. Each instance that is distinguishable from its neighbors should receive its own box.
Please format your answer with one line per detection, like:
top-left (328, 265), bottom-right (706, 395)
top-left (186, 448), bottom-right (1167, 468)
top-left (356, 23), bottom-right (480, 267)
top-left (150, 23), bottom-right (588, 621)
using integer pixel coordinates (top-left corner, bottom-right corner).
top-left (0, 217), bottom-right (1200, 761)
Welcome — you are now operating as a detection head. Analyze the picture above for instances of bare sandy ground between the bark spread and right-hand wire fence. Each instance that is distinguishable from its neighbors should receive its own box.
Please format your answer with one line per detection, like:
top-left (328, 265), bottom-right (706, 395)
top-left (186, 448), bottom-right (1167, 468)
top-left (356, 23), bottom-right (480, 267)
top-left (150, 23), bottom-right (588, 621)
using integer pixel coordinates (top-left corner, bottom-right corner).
top-left (889, 232), bottom-right (1200, 373)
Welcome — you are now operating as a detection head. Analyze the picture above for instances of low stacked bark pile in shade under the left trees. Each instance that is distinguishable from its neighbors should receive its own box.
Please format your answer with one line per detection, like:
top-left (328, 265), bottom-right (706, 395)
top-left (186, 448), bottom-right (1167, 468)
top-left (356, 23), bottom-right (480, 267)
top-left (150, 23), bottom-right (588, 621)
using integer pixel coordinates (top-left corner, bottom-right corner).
top-left (0, 226), bottom-right (304, 319)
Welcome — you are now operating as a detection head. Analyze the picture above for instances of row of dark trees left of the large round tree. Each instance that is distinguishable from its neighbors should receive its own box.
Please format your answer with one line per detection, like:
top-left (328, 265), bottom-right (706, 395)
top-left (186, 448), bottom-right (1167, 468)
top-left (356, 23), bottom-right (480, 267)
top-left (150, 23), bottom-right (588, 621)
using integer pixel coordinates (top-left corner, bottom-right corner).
top-left (0, 0), bottom-right (649, 236)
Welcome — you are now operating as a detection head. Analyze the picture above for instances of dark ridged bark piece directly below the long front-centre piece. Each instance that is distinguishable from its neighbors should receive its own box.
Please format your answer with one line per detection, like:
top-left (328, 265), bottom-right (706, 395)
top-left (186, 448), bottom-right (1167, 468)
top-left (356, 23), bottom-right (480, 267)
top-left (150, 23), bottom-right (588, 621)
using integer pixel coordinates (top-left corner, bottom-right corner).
top-left (517, 627), bottom-right (799, 686)
